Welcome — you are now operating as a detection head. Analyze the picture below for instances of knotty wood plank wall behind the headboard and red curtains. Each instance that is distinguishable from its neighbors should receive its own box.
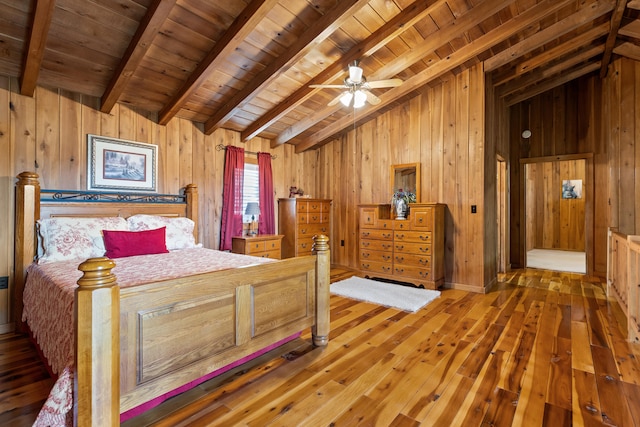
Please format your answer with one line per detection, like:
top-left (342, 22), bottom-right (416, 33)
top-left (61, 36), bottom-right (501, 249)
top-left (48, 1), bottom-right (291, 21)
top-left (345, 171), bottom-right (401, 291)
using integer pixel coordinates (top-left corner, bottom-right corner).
top-left (0, 76), bottom-right (317, 333)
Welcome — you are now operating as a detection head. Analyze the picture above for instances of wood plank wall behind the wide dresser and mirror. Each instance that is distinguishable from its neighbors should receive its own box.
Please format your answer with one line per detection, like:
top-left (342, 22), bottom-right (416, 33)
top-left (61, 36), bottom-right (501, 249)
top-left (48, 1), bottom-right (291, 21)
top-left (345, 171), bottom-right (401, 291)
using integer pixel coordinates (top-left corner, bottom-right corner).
top-left (318, 65), bottom-right (484, 291)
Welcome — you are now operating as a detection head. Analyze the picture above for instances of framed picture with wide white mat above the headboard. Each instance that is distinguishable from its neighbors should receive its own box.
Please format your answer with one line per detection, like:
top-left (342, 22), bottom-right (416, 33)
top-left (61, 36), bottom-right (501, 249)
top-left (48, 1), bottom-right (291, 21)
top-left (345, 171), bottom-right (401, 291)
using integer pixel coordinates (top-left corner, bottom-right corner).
top-left (87, 134), bottom-right (158, 193)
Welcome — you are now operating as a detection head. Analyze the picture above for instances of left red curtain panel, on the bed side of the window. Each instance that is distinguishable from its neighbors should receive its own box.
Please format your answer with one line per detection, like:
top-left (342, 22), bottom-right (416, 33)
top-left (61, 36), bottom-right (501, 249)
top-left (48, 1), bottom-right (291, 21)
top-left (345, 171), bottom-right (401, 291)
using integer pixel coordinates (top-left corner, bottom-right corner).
top-left (220, 145), bottom-right (244, 251)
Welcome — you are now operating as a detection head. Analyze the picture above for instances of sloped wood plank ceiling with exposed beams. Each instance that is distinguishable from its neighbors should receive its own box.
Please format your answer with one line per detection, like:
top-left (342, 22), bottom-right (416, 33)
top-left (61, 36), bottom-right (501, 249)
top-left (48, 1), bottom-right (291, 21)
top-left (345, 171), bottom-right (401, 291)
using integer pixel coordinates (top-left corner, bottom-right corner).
top-left (0, 0), bottom-right (640, 152)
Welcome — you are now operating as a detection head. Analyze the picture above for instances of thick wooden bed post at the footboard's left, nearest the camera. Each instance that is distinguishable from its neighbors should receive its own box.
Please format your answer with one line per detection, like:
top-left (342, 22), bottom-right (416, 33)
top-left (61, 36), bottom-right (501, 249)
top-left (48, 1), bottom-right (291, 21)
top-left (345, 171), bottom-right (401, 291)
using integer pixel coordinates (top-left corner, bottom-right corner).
top-left (74, 257), bottom-right (120, 426)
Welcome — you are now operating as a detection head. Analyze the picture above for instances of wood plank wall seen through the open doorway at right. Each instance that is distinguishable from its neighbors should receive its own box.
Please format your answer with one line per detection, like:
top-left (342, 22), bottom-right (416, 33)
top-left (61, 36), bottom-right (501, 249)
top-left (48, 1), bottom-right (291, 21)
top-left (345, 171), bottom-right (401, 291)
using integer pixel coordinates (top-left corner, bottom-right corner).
top-left (526, 159), bottom-right (591, 252)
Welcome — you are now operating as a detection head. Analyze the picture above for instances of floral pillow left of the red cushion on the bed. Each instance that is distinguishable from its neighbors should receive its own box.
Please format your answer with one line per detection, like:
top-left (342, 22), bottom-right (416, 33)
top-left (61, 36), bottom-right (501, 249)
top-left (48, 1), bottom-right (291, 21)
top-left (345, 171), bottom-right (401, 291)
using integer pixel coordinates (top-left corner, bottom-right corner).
top-left (38, 217), bottom-right (128, 264)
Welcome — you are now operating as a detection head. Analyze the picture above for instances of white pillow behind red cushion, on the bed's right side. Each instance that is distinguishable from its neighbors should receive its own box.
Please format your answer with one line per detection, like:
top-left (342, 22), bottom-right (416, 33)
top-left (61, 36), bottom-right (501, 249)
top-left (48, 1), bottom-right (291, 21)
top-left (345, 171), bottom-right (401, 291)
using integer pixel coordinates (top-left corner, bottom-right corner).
top-left (127, 215), bottom-right (196, 251)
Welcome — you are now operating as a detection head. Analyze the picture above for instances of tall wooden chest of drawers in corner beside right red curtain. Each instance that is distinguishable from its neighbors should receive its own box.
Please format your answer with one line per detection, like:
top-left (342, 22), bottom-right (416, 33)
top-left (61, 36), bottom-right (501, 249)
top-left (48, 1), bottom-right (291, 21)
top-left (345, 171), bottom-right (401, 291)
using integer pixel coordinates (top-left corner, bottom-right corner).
top-left (278, 197), bottom-right (331, 258)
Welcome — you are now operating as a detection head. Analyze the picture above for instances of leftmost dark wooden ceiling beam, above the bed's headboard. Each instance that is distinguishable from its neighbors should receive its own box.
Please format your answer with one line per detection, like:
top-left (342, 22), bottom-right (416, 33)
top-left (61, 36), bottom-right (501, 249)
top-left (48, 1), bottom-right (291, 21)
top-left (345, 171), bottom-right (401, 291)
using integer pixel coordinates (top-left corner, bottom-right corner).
top-left (20, 0), bottom-right (56, 96)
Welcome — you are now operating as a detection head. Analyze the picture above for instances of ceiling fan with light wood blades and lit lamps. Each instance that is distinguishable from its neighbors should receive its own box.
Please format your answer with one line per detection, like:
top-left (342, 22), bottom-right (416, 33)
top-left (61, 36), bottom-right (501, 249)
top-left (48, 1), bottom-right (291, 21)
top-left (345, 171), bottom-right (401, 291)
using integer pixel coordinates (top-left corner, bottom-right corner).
top-left (309, 61), bottom-right (402, 108)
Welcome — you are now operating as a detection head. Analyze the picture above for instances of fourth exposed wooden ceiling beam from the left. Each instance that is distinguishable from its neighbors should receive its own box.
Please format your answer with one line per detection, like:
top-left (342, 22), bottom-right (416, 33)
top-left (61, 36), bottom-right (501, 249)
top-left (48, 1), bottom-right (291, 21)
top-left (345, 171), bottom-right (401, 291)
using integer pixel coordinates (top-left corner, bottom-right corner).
top-left (204, 0), bottom-right (369, 134)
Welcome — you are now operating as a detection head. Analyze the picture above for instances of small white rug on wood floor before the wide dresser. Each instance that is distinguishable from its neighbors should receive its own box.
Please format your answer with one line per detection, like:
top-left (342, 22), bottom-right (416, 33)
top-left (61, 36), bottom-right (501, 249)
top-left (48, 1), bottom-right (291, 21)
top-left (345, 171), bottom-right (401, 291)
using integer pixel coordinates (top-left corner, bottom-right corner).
top-left (330, 276), bottom-right (440, 313)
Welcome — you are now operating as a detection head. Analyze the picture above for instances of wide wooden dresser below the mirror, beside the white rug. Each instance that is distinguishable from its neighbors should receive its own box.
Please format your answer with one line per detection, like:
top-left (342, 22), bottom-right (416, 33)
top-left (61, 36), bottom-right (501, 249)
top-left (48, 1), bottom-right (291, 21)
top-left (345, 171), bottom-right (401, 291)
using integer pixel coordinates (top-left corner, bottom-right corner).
top-left (358, 203), bottom-right (445, 289)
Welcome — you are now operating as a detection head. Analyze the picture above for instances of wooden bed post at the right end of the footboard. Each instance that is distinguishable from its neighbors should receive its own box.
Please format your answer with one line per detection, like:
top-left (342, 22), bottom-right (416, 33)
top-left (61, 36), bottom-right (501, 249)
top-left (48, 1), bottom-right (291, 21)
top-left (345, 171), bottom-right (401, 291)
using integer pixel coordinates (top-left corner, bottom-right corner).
top-left (311, 234), bottom-right (331, 346)
